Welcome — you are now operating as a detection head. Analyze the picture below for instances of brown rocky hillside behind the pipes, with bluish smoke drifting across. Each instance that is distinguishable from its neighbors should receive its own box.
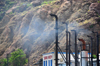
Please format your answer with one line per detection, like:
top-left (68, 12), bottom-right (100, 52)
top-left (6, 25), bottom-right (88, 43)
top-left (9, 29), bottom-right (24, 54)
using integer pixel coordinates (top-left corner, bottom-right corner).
top-left (0, 0), bottom-right (100, 65)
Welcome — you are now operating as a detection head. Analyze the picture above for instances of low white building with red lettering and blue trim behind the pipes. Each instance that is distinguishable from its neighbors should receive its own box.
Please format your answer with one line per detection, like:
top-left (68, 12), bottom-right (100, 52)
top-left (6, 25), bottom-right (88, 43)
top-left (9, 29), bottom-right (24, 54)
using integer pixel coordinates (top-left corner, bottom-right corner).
top-left (43, 52), bottom-right (100, 66)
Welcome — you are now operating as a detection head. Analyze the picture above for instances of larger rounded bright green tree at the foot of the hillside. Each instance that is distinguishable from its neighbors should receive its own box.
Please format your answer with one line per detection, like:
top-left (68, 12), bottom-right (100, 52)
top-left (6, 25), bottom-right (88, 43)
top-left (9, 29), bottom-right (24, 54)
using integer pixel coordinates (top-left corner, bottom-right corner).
top-left (9, 49), bottom-right (28, 66)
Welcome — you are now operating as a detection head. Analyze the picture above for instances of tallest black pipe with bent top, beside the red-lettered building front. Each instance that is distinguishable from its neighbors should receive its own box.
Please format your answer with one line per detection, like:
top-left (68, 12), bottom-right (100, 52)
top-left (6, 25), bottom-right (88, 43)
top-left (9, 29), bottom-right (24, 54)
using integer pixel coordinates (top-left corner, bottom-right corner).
top-left (50, 14), bottom-right (58, 66)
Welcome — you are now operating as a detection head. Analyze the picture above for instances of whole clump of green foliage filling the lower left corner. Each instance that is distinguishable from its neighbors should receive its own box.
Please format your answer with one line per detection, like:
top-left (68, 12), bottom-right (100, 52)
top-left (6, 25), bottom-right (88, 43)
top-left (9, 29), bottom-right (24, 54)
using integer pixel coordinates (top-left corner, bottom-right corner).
top-left (0, 49), bottom-right (28, 66)
